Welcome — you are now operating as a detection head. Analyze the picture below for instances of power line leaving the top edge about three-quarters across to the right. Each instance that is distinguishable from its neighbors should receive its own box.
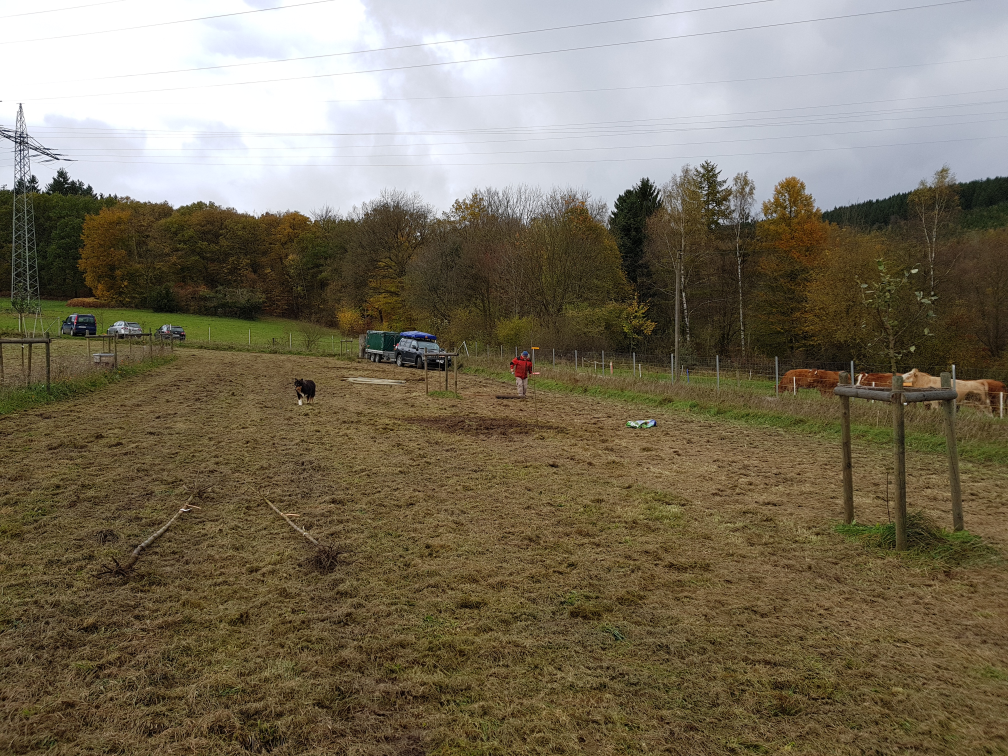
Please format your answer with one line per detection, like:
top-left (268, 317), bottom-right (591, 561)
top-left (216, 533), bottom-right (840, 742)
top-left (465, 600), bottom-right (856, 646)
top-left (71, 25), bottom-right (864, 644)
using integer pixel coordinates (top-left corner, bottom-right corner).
top-left (40, 0), bottom-right (777, 85)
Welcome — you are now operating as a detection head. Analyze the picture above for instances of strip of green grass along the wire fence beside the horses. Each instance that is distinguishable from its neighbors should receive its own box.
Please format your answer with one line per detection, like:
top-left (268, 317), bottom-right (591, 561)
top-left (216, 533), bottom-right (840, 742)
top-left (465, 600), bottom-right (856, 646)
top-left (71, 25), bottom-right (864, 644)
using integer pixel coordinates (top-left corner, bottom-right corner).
top-left (466, 367), bottom-right (1008, 465)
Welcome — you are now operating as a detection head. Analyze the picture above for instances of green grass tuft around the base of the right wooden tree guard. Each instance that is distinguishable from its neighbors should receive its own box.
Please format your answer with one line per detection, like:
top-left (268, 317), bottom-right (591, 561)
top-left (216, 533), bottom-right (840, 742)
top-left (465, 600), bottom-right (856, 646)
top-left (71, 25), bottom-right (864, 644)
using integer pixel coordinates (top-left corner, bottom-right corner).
top-left (837, 511), bottom-right (1001, 566)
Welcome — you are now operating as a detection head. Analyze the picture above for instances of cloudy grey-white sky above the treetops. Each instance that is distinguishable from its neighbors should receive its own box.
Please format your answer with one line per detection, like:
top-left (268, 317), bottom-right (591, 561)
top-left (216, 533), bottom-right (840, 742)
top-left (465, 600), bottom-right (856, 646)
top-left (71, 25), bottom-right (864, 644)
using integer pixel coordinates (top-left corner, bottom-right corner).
top-left (0, 0), bottom-right (1008, 213)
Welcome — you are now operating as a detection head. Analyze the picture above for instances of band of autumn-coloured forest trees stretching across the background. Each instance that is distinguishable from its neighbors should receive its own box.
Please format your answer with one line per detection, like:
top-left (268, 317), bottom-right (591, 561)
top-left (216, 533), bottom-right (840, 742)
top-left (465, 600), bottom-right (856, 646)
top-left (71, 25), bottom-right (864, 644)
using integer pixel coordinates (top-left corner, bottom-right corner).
top-left (0, 168), bottom-right (1008, 376)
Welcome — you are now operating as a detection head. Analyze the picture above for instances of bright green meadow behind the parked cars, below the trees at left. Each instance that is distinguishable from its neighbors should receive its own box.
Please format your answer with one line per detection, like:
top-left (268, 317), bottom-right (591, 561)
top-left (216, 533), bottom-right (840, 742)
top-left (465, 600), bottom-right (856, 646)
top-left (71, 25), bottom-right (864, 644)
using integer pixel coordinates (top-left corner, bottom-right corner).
top-left (0, 301), bottom-right (348, 354)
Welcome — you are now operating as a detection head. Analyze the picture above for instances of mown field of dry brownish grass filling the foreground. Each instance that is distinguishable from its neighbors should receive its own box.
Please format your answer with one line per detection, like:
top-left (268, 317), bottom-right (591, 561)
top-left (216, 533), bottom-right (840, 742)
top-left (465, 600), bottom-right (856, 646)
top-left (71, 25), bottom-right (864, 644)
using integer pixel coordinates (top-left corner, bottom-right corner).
top-left (0, 350), bottom-right (1008, 754)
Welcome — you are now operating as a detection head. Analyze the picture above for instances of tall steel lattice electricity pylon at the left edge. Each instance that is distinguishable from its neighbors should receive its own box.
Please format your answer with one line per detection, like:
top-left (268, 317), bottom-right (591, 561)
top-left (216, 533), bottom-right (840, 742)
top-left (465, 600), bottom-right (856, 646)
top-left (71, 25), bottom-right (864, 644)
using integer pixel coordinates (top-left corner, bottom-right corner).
top-left (0, 104), bottom-right (65, 333)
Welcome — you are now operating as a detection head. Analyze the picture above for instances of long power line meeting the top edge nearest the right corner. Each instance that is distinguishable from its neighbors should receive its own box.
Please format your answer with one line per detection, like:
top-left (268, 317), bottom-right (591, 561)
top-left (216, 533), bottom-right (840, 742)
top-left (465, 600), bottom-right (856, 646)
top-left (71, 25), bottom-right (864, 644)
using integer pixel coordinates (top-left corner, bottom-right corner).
top-left (19, 0), bottom-right (980, 102)
